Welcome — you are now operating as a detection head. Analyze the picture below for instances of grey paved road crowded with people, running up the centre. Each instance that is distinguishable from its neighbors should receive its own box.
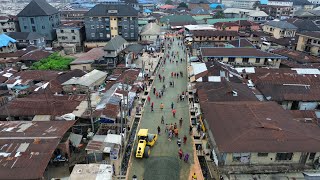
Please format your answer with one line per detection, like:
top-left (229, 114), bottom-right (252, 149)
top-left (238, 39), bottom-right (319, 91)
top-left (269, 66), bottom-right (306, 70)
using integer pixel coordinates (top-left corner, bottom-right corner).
top-left (129, 35), bottom-right (193, 180)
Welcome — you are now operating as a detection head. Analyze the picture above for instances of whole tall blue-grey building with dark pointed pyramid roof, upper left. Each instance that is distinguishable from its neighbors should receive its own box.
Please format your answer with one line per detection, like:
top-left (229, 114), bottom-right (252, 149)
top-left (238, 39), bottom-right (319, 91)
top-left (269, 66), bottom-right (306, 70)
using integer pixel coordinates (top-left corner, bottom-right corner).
top-left (17, 0), bottom-right (60, 43)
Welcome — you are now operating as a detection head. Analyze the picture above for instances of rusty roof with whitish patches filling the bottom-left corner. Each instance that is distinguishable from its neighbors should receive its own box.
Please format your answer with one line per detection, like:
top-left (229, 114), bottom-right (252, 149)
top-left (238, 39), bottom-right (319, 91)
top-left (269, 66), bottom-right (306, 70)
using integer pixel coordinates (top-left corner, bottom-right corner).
top-left (0, 121), bottom-right (75, 180)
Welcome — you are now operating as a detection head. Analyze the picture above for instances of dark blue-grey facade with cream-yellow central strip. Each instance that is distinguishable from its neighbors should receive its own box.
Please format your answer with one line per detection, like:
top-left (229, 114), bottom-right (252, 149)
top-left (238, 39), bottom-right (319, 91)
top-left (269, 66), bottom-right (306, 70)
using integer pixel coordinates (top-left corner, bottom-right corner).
top-left (85, 16), bottom-right (139, 41)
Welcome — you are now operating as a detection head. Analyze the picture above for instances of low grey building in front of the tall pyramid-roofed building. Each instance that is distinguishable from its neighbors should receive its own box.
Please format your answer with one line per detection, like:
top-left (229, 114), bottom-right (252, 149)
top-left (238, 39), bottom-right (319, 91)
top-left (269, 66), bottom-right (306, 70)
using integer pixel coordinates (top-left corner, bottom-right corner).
top-left (6, 32), bottom-right (46, 49)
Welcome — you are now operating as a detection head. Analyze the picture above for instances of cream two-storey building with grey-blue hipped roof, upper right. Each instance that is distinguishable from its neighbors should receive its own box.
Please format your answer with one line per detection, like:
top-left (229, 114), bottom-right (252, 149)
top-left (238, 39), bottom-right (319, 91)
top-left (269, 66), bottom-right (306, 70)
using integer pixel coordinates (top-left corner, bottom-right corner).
top-left (262, 21), bottom-right (298, 39)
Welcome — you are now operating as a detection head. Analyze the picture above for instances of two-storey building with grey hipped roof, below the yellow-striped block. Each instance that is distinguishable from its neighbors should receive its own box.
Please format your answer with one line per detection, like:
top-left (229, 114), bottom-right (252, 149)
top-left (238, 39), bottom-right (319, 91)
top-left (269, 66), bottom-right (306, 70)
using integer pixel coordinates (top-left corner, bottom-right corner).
top-left (92, 35), bottom-right (128, 69)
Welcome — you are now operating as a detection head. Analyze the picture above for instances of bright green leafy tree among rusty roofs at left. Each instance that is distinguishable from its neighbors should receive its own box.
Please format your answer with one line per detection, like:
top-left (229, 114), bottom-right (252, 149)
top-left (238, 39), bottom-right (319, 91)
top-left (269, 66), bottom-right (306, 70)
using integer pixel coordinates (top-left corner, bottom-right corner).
top-left (31, 52), bottom-right (73, 70)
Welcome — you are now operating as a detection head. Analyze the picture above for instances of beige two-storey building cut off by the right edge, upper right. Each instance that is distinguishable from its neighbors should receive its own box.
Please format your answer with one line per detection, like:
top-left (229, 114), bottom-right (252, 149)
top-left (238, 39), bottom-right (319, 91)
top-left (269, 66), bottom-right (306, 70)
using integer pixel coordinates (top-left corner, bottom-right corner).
top-left (297, 31), bottom-right (320, 56)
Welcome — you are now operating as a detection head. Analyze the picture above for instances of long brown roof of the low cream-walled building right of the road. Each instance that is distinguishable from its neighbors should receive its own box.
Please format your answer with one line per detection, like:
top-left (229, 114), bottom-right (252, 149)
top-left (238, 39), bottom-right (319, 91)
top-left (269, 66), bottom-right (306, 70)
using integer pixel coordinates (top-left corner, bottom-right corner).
top-left (200, 48), bottom-right (286, 59)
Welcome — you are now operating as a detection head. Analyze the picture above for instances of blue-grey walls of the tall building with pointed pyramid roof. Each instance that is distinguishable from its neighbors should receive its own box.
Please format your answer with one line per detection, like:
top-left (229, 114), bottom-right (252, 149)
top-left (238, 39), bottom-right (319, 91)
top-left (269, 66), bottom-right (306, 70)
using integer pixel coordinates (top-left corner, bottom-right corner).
top-left (18, 13), bottom-right (60, 41)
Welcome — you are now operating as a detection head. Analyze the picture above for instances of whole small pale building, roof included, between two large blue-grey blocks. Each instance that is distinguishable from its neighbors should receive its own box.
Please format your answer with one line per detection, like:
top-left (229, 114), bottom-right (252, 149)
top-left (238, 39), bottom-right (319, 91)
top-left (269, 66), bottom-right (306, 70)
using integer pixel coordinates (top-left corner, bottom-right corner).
top-left (56, 22), bottom-right (85, 47)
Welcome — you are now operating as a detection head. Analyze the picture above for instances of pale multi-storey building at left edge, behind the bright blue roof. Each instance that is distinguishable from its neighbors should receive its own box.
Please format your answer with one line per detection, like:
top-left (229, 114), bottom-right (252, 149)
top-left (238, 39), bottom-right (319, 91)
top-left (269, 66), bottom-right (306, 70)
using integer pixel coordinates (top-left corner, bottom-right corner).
top-left (0, 15), bottom-right (20, 33)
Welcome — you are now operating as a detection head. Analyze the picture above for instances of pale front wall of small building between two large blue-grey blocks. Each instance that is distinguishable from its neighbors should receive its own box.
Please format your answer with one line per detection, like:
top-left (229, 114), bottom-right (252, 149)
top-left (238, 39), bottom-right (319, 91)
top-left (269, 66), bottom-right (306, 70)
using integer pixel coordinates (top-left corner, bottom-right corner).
top-left (56, 27), bottom-right (84, 46)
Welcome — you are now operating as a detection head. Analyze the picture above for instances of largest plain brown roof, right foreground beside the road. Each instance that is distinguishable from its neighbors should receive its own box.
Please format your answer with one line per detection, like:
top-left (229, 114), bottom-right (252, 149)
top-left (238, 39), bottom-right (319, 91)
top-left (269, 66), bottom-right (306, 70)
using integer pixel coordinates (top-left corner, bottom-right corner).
top-left (201, 101), bottom-right (320, 152)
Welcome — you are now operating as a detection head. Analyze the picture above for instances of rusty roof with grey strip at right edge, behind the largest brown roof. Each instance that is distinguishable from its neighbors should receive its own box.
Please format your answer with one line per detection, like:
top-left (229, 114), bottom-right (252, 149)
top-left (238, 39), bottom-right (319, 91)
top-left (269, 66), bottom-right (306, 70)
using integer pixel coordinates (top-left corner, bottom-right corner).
top-left (248, 68), bottom-right (320, 101)
